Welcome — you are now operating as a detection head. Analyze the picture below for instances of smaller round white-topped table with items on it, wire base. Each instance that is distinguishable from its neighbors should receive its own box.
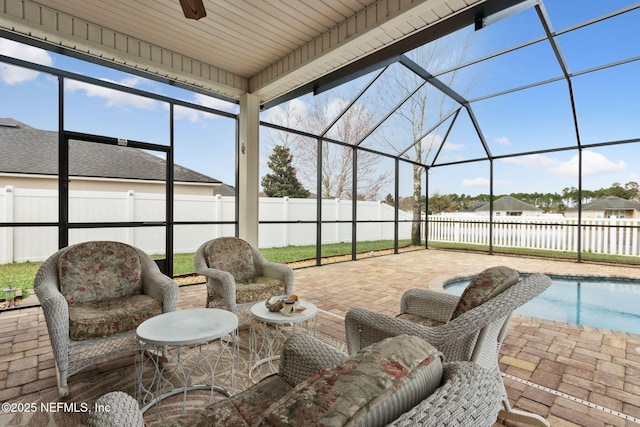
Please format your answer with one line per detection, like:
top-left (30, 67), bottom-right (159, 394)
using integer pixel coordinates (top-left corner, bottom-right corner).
top-left (249, 300), bottom-right (318, 382)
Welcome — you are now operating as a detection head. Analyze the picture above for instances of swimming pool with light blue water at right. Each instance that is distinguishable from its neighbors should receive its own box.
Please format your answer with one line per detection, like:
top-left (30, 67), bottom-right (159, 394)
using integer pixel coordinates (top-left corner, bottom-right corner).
top-left (444, 276), bottom-right (640, 334)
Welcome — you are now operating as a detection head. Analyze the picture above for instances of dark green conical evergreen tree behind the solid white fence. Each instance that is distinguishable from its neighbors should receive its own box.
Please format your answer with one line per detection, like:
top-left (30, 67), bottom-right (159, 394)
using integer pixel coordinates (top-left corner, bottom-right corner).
top-left (262, 145), bottom-right (309, 199)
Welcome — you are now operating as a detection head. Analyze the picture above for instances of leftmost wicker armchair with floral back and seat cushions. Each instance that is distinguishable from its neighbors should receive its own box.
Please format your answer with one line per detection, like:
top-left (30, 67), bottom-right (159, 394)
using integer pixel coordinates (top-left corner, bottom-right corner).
top-left (34, 241), bottom-right (179, 397)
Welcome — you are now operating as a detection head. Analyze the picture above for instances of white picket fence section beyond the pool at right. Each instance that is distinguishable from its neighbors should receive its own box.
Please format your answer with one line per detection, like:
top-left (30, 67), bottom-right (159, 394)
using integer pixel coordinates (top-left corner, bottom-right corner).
top-left (428, 215), bottom-right (640, 256)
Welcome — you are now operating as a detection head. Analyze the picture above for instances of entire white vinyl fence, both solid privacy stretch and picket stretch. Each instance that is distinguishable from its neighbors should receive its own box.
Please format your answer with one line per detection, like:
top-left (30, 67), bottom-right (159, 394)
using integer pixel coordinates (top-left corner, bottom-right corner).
top-left (0, 186), bottom-right (640, 264)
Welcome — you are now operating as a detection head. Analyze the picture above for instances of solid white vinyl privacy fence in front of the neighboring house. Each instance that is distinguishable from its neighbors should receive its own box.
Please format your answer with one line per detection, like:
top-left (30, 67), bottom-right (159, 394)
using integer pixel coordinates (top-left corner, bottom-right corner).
top-left (0, 186), bottom-right (411, 264)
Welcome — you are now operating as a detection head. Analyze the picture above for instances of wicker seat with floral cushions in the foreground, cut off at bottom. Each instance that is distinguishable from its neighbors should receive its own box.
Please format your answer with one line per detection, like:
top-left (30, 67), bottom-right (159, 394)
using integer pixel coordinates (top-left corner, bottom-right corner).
top-left (88, 334), bottom-right (502, 427)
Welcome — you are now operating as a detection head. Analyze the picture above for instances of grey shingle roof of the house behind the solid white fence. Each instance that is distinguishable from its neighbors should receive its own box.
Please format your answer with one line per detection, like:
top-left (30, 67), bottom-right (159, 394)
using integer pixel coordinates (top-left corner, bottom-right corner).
top-left (0, 118), bottom-right (221, 184)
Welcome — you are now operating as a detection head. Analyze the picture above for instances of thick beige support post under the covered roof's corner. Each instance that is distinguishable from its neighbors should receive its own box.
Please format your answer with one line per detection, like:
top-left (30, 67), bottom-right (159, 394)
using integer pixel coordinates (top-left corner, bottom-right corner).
top-left (237, 93), bottom-right (260, 248)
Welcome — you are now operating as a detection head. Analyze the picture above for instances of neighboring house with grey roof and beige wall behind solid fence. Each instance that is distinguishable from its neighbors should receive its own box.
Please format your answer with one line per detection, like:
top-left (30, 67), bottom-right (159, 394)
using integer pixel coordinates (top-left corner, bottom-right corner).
top-left (0, 118), bottom-right (230, 196)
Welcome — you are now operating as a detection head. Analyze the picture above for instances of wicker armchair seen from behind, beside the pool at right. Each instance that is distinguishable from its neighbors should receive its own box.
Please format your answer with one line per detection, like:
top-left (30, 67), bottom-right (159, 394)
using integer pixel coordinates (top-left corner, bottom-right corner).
top-left (345, 267), bottom-right (551, 426)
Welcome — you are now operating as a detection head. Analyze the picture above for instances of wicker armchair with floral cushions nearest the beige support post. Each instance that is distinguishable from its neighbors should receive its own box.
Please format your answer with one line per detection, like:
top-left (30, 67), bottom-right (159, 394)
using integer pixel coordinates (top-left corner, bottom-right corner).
top-left (193, 237), bottom-right (293, 323)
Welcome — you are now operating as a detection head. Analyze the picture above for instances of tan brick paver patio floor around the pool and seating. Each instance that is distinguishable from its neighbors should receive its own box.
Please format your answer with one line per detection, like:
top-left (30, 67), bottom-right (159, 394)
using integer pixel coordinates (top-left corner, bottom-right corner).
top-left (0, 250), bottom-right (640, 427)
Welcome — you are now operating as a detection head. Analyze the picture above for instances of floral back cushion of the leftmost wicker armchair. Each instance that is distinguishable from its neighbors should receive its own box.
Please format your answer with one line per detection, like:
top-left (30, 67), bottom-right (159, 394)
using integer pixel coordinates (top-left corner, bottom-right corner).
top-left (58, 241), bottom-right (142, 305)
